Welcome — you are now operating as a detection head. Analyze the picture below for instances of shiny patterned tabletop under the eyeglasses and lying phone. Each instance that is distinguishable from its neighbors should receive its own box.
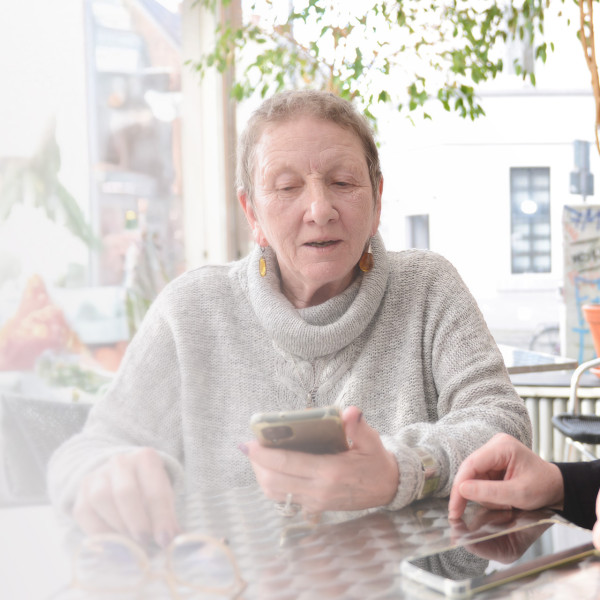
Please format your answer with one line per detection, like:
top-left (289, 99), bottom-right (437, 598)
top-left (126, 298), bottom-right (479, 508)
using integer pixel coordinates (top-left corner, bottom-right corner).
top-left (0, 487), bottom-right (600, 600)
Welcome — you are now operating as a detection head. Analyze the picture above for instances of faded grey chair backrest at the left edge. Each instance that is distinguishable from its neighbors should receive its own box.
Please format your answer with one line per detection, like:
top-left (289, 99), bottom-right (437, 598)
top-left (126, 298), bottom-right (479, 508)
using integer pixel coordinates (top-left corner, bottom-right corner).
top-left (0, 392), bottom-right (91, 505)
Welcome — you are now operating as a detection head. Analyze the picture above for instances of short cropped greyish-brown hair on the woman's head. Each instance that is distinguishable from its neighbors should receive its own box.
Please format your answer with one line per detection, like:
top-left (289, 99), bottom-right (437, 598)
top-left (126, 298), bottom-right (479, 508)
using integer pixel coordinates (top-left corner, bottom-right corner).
top-left (237, 90), bottom-right (381, 202)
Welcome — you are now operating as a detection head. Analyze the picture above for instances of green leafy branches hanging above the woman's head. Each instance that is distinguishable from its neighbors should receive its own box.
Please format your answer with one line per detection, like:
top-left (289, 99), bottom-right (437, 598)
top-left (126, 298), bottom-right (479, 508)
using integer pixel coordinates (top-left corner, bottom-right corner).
top-left (194, 0), bottom-right (564, 119)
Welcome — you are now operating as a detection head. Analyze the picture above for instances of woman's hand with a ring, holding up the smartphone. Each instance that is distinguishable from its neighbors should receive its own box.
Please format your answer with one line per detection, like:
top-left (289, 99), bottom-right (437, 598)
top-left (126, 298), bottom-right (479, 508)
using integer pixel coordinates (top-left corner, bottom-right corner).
top-left (240, 406), bottom-right (400, 513)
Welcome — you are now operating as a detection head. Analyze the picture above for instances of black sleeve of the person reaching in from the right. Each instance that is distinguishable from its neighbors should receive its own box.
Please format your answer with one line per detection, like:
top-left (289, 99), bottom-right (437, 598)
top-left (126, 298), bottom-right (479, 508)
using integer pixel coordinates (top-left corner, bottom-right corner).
top-left (555, 460), bottom-right (600, 529)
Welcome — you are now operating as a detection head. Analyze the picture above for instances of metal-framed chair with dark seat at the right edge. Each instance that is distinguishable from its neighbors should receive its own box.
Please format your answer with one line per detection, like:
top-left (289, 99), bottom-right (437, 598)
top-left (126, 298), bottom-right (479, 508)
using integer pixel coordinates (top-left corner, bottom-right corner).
top-left (552, 358), bottom-right (600, 460)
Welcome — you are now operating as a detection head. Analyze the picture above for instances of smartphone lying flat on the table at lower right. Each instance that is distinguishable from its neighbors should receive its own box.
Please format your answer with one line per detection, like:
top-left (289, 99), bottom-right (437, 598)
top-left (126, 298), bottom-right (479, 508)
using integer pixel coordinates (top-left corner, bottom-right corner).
top-left (401, 521), bottom-right (596, 598)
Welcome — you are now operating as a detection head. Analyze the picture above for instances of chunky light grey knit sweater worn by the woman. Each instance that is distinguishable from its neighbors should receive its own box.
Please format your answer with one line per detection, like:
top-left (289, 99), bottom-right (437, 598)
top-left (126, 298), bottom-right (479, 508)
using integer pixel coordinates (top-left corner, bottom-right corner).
top-left (49, 236), bottom-right (531, 511)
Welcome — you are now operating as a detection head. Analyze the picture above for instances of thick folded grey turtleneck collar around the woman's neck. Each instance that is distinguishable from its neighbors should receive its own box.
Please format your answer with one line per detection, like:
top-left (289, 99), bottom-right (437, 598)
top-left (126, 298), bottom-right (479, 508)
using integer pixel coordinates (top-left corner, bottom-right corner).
top-left (240, 233), bottom-right (389, 360)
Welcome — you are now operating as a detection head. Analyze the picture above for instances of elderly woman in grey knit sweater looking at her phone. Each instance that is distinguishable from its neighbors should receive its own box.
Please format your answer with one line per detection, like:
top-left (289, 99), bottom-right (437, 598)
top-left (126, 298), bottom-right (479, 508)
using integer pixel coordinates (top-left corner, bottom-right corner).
top-left (49, 91), bottom-right (531, 545)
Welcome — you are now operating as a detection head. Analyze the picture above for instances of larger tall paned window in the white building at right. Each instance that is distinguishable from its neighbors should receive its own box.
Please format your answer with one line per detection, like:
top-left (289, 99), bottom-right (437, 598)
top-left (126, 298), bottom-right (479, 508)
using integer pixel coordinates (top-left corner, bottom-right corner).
top-left (510, 167), bottom-right (552, 273)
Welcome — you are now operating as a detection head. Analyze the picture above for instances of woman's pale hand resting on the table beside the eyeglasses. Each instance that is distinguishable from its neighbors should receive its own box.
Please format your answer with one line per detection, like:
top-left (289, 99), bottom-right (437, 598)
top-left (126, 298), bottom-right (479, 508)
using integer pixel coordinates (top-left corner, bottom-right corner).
top-left (73, 448), bottom-right (179, 547)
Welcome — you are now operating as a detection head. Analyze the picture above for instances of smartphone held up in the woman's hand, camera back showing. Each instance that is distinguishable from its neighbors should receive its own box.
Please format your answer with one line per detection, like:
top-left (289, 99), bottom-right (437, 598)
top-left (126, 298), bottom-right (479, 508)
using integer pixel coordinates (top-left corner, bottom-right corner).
top-left (250, 406), bottom-right (348, 454)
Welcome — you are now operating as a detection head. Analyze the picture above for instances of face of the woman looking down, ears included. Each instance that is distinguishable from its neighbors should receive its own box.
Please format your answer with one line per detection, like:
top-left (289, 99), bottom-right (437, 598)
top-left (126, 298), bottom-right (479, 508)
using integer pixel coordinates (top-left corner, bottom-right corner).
top-left (239, 116), bottom-right (382, 307)
